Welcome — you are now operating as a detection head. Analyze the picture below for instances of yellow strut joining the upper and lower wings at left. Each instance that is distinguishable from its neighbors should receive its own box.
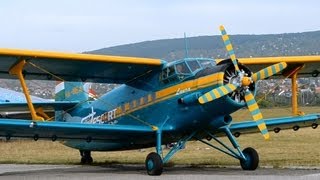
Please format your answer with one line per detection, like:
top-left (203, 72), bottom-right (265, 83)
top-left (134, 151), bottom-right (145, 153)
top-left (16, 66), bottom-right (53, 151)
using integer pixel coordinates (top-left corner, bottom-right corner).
top-left (9, 59), bottom-right (44, 121)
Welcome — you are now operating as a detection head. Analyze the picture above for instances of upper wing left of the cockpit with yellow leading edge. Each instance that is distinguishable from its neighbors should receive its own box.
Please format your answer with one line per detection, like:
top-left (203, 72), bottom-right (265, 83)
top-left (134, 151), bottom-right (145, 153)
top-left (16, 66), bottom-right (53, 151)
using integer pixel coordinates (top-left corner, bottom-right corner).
top-left (0, 49), bottom-right (165, 83)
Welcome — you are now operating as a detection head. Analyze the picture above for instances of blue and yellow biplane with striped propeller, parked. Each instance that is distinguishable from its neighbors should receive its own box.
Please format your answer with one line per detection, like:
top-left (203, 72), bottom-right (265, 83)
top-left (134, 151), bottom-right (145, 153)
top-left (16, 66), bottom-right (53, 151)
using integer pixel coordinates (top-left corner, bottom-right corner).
top-left (0, 26), bottom-right (320, 175)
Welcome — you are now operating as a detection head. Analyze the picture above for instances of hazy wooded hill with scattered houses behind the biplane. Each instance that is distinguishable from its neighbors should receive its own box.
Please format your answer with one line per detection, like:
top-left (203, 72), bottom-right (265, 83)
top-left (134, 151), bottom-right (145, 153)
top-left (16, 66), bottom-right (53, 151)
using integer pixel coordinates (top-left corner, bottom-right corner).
top-left (85, 31), bottom-right (320, 61)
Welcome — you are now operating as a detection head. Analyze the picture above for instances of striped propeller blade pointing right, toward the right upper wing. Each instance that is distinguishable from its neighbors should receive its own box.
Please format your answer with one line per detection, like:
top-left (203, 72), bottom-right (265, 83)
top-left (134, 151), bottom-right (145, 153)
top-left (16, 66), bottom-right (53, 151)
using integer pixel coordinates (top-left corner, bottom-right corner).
top-left (251, 62), bottom-right (287, 82)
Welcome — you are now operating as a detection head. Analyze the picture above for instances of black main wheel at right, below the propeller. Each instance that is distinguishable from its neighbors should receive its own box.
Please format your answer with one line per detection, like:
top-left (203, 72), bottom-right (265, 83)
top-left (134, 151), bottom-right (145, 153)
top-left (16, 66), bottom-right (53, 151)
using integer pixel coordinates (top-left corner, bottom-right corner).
top-left (240, 147), bottom-right (259, 171)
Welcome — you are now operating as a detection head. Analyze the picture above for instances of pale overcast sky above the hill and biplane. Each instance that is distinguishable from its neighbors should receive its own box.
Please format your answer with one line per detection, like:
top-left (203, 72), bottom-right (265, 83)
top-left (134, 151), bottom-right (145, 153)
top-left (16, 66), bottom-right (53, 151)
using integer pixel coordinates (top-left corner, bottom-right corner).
top-left (0, 0), bottom-right (320, 52)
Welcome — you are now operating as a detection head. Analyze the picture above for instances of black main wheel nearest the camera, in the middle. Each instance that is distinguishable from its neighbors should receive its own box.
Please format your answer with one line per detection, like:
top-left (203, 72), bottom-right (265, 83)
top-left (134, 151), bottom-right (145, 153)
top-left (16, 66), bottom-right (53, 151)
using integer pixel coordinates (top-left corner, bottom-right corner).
top-left (146, 152), bottom-right (163, 176)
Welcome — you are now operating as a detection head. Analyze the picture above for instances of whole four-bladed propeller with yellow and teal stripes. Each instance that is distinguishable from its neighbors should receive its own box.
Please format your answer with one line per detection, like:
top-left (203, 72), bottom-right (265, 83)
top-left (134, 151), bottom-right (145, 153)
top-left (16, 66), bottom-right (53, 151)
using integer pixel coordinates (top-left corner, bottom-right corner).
top-left (198, 26), bottom-right (287, 139)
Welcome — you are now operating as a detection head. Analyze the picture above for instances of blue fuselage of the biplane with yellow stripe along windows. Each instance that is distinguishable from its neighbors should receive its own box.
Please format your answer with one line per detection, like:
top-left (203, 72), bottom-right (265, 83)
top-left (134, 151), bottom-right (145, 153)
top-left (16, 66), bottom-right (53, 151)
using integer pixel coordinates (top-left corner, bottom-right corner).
top-left (65, 58), bottom-right (248, 151)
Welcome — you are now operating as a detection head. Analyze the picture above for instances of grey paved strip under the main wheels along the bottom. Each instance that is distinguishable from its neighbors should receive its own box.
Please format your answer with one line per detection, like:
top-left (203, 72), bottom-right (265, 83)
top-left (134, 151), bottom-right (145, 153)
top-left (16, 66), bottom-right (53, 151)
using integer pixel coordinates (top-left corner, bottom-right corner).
top-left (0, 164), bottom-right (320, 180)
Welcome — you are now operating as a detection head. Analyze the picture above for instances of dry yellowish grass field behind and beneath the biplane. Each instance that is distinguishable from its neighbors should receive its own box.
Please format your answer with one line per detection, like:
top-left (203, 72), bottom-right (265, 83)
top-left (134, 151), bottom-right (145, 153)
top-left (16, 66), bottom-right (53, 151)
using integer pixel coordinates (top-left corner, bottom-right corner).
top-left (0, 107), bottom-right (320, 167)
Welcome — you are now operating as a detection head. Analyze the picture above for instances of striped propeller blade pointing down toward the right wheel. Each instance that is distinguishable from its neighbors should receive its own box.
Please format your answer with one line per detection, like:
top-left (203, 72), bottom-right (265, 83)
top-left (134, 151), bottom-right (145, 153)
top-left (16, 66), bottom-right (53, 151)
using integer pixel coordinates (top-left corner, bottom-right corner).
top-left (244, 91), bottom-right (270, 140)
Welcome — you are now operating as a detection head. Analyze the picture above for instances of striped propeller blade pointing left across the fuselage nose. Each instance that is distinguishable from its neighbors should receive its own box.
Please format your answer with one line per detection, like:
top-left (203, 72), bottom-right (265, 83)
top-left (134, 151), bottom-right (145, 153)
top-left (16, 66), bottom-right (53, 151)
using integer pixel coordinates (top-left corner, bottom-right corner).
top-left (198, 84), bottom-right (237, 104)
